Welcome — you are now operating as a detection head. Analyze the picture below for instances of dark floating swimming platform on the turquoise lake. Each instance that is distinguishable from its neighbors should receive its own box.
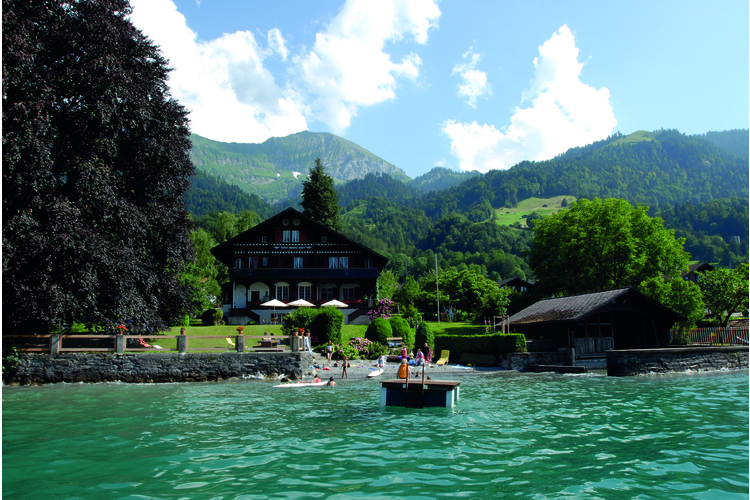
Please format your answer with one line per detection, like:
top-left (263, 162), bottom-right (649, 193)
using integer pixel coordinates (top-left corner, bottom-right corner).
top-left (380, 378), bottom-right (461, 408)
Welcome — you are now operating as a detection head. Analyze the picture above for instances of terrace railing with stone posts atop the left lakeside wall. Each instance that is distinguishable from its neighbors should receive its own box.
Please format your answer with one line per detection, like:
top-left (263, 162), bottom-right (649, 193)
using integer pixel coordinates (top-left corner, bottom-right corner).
top-left (2, 335), bottom-right (302, 354)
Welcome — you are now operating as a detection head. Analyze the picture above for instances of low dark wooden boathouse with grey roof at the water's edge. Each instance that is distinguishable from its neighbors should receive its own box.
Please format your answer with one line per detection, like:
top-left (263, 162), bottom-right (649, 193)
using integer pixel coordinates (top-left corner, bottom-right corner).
top-left (508, 288), bottom-right (687, 357)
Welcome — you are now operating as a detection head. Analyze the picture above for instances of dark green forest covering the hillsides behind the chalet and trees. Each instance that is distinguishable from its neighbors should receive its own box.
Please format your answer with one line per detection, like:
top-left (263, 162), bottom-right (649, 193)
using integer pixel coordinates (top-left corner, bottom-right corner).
top-left (188, 130), bottom-right (748, 304)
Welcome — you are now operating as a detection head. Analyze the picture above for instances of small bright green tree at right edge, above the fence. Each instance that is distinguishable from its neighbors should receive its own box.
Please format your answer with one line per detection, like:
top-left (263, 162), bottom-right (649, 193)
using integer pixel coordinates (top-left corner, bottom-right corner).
top-left (698, 264), bottom-right (748, 327)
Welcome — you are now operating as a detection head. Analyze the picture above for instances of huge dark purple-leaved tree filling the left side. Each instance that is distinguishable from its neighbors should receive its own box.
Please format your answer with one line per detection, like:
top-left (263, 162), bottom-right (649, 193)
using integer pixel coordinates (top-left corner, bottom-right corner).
top-left (2, 0), bottom-right (194, 334)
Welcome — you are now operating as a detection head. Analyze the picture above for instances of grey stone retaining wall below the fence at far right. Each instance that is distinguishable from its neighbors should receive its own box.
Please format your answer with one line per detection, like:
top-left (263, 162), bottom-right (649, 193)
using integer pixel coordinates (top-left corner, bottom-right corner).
top-left (607, 346), bottom-right (748, 377)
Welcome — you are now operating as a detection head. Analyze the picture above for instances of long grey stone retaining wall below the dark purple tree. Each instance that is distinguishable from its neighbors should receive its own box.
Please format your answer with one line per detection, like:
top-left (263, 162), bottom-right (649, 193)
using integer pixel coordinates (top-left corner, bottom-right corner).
top-left (5, 352), bottom-right (303, 385)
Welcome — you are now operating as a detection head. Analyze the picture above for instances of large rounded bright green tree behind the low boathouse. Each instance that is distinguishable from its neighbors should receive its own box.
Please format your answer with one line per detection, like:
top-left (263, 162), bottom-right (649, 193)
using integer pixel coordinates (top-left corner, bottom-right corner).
top-left (529, 198), bottom-right (689, 294)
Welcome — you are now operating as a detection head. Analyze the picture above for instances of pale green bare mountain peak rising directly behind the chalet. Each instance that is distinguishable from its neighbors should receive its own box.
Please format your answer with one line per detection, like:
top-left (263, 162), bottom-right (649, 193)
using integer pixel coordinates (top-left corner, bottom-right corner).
top-left (191, 132), bottom-right (410, 203)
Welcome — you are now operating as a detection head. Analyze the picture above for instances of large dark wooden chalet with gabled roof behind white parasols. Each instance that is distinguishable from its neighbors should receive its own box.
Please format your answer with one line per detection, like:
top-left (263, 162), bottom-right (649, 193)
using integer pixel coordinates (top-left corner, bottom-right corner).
top-left (211, 207), bottom-right (388, 324)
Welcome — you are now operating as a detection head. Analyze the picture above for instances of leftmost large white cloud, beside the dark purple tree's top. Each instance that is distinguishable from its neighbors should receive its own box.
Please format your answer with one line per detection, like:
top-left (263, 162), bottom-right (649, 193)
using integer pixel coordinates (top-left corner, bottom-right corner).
top-left (131, 0), bottom-right (307, 142)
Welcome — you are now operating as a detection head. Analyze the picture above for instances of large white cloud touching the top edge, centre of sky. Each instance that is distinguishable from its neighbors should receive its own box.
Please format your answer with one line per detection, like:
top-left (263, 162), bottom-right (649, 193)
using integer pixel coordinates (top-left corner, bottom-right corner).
top-left (295, 0), bottom-right (440, 133)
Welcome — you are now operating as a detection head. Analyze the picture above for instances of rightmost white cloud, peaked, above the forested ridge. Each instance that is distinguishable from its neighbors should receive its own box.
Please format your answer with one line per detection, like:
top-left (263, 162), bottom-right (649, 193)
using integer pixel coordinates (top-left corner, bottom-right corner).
top-left (443, 25), bottom-right (617, 172)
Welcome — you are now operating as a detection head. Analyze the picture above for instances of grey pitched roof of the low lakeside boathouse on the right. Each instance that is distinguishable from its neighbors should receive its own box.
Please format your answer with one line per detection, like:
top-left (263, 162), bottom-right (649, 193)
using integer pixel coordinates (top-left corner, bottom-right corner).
top-left (509, 288), bottom-right (687, 325)
